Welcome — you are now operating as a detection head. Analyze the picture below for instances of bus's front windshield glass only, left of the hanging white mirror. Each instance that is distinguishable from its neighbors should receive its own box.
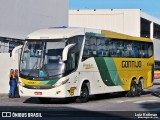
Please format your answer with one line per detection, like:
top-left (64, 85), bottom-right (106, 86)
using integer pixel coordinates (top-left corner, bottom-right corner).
top-left (20, 40), bottom-right (65, 79)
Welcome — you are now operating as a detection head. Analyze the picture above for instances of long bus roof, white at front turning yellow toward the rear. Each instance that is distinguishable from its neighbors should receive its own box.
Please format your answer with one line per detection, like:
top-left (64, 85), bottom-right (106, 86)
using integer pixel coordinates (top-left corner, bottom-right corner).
top-left (27, 27), bottom-right (152, 42)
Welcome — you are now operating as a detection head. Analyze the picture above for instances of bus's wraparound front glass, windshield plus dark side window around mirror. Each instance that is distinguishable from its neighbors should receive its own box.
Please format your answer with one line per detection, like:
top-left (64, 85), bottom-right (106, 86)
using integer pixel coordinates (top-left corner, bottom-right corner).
top-left (20, 36), bottom-right (84, 80)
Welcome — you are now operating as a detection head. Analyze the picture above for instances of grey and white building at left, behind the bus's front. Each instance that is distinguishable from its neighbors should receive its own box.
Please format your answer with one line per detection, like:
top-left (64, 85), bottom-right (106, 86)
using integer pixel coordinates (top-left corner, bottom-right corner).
top-left (0, 0), bottom-right (68, 93)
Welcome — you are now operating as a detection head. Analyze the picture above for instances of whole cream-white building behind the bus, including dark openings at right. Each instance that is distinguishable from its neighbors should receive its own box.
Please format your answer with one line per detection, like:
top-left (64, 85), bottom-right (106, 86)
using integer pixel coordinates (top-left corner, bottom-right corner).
top-left (69, 9), bottom-right (160, 69)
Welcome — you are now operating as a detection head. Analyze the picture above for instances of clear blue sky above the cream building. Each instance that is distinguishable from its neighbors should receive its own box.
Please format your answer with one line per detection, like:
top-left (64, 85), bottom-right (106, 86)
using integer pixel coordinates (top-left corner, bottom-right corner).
top-left (69, 0), bottom-right (160, 19)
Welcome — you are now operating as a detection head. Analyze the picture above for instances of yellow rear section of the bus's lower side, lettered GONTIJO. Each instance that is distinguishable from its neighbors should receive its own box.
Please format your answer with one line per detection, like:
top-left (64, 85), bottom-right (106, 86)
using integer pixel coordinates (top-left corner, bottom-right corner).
top-left (114, 57), bottom-right (154, 91)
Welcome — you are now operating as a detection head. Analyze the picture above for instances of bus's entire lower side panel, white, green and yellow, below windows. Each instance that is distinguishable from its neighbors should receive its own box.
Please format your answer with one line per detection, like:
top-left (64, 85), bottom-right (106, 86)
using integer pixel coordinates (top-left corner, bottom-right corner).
top-left (77, 57), bottom-right (153, 94)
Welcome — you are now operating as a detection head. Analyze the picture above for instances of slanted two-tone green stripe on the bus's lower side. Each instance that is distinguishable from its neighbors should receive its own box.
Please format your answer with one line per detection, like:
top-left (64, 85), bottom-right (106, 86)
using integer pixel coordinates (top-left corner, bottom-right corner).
top-left (95, 57), bottom-right (122, 86)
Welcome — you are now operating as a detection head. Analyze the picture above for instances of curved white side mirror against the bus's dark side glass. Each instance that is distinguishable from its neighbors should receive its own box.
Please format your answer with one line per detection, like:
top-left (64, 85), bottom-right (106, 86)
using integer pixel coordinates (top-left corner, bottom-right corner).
top-left (62, 44), bottom-right (75, 62)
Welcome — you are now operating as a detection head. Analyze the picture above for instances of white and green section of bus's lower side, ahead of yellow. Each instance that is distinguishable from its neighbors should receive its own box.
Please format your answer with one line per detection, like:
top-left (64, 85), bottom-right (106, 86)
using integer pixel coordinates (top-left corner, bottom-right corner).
top-left (77, 57), bottom-right (124, 94)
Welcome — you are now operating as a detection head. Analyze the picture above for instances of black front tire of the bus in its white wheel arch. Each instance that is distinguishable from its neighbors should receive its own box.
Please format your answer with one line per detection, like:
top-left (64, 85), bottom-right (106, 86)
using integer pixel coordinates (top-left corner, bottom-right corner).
top-left (76, 83), bottom-right (89, 103)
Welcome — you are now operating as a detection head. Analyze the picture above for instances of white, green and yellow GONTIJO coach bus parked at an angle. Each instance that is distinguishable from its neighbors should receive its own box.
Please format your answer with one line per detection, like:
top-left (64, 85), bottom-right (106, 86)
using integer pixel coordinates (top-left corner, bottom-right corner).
top-left (13, 28), bottom-right (154, 102)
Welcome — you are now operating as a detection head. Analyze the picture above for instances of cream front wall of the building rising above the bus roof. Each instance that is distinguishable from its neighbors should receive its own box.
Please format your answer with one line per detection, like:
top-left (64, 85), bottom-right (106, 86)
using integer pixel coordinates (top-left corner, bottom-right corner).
top-left (69, 9), bottom-right (140, 36)
